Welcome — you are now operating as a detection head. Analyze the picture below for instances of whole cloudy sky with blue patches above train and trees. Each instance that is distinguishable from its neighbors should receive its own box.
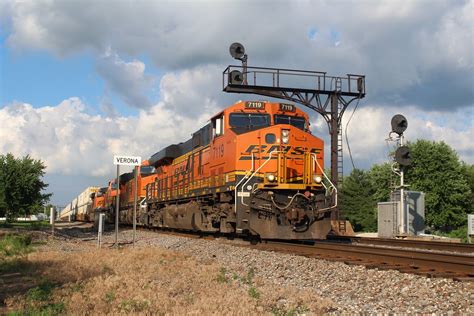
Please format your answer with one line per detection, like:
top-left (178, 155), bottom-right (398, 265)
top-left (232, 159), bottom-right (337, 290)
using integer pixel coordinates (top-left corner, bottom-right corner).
top-left (0, 0), bottom-right (474, 204)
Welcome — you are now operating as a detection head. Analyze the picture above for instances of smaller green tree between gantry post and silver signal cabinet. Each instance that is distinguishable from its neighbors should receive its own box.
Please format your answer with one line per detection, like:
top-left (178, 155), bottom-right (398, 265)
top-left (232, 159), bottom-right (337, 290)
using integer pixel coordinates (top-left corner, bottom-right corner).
top-left (340, 169), bottom-right (377, 231)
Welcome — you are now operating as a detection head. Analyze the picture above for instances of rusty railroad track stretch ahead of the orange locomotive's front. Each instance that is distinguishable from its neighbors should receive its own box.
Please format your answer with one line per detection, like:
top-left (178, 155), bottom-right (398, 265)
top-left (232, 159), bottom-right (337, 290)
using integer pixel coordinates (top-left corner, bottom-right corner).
top-left (253, 242), bottom-right (474, 281)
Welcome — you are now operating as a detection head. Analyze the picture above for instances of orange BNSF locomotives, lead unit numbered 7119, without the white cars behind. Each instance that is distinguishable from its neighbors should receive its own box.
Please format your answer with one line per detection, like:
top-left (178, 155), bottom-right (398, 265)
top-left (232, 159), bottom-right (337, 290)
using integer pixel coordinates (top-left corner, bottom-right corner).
top-left (86, 101), bottom-right (348, 240)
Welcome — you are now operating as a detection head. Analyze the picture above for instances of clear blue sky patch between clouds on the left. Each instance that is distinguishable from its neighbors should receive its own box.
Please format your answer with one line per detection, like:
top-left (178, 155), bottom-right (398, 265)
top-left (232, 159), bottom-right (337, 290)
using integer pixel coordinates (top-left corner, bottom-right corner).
top-left (0, 34), bottom-right (162, 116)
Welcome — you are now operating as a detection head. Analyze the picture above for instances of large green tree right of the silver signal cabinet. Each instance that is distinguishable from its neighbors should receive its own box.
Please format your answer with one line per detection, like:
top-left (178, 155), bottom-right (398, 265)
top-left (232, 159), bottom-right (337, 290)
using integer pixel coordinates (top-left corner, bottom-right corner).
top-left (406, 140), bottom-right (472, 232)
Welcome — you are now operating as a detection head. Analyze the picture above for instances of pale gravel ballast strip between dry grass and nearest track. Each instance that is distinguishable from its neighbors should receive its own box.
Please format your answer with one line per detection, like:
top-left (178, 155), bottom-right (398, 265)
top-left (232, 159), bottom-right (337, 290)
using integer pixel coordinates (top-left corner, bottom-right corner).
top-left (65, 230), bottom-right (474, 315)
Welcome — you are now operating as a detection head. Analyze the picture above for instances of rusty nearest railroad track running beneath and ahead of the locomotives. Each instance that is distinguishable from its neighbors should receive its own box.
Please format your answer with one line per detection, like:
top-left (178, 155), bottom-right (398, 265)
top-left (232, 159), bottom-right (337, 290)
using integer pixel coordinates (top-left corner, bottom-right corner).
top-left (52, 222), bottom-right (474, 281)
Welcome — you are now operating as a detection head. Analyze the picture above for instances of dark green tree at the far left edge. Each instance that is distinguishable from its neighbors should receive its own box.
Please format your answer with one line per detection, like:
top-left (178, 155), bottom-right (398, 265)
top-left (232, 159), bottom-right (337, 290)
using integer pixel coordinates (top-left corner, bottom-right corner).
top-left (0, 154), bottom-right (51, 221)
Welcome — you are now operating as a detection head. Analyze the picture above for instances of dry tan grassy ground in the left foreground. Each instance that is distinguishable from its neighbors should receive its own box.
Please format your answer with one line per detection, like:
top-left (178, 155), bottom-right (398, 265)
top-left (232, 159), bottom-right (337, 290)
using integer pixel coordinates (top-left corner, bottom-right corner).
top-left (0, 225), bottom-right (333, 315)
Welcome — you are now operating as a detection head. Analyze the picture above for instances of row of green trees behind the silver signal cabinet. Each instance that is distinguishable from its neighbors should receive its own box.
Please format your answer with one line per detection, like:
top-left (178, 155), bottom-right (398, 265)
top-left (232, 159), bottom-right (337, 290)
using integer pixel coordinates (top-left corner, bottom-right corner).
top-left (341, 140), bottom-right (474, 233)
